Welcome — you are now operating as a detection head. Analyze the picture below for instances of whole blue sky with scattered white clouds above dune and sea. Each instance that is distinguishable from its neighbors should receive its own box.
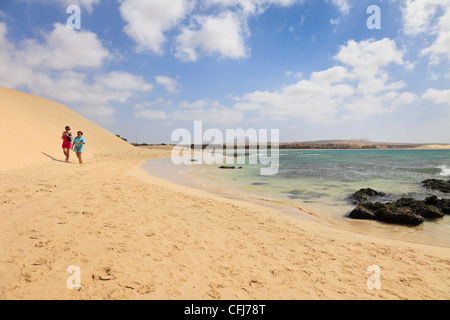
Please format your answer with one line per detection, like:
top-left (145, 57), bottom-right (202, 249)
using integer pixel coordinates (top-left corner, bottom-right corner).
top-left (0, 0), bottom-right (450, 143)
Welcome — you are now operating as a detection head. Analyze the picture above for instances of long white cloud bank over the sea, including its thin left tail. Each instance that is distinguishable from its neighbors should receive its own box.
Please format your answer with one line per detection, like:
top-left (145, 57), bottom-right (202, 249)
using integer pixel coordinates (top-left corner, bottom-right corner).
top-left (135, 39), bottom-right (418, 124)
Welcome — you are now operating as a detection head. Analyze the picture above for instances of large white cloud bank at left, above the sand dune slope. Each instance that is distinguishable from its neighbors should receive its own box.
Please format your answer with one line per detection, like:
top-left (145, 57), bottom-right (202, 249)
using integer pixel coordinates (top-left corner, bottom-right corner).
top-left (0, 23), bottom-right (153, 122)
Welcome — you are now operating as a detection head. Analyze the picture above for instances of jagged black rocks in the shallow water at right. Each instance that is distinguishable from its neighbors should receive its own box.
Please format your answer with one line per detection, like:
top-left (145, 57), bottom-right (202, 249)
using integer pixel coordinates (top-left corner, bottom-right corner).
top-left (348, 180), bottom-right (450, 226)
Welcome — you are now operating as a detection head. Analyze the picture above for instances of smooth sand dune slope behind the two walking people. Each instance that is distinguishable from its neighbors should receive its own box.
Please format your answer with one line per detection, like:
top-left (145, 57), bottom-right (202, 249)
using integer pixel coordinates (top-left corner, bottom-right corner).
top-left (0, 88), bottom-right (132, 171)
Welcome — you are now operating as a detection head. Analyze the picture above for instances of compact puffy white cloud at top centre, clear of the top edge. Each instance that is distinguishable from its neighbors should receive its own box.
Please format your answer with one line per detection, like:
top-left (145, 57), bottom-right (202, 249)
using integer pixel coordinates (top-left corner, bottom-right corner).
top-left (175, 11), bottom-right (249, 61)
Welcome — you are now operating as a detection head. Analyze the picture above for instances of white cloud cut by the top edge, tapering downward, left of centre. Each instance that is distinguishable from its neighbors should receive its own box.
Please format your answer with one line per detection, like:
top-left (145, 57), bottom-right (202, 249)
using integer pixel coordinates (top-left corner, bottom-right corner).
top-left (120, 0), bottom-right (194, 55)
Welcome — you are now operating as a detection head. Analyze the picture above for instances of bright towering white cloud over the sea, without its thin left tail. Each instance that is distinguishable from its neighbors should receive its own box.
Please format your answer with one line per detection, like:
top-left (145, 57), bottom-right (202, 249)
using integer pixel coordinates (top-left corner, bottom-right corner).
top-left (234, 39), bottom-right (417, 122)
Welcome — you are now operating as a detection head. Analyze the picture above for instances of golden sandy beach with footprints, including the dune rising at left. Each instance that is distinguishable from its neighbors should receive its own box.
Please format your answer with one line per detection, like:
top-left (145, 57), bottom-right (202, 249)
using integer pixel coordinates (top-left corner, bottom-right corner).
top-left (0, 89), bottom-right (450, 300)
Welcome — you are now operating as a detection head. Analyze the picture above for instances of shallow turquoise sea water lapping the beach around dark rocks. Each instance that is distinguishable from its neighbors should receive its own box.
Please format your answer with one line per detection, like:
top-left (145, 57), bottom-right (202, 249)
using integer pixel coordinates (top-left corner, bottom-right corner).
top-left (144, 150), bottom-right (450, 247)
